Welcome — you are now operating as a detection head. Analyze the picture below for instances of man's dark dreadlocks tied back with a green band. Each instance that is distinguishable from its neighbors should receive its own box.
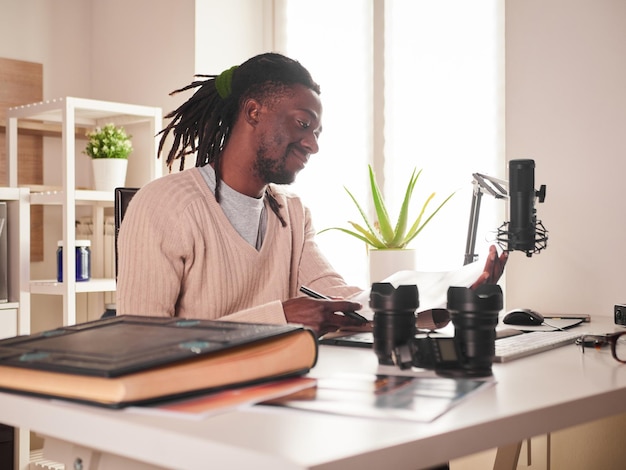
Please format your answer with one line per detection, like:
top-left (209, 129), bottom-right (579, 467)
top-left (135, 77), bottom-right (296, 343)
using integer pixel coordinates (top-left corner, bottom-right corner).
top-left (158, 53), bottom-right (320, 226)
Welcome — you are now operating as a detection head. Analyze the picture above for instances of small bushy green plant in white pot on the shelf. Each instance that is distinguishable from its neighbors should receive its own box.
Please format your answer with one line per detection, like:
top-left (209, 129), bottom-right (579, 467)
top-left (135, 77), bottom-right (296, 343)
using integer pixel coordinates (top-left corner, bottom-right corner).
top-left (83, 123), bottom-right (133, 191)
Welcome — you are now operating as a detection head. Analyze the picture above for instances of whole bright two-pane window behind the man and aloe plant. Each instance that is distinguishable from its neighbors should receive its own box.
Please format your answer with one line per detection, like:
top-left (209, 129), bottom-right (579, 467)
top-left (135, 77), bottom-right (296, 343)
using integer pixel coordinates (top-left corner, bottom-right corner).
top-left (277, 0), bottom-right (504, 286)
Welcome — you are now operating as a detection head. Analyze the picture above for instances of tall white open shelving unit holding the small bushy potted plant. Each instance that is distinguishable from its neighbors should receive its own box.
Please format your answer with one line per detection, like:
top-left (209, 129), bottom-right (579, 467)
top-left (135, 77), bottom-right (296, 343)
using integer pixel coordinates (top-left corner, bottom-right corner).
top-left (6, 97), bottom-right (162, 325)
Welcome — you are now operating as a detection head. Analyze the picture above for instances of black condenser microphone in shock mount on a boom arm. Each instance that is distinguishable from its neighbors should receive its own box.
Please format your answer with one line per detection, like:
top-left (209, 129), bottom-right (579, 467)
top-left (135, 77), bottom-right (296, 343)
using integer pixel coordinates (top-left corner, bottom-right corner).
top-left (498, 159), bottom-right (548, 256)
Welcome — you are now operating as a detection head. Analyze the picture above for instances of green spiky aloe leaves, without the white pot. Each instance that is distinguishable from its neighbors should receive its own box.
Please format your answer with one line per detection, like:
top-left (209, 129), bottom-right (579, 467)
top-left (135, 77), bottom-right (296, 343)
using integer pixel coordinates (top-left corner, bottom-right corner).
top-left (320, 165), bottom-right (454, 250)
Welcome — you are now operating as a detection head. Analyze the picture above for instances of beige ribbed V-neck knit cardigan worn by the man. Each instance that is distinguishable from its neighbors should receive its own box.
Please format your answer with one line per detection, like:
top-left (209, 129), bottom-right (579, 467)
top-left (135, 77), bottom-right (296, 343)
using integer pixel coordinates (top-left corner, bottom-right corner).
top-left (117, 168), bottom-right (360, 323)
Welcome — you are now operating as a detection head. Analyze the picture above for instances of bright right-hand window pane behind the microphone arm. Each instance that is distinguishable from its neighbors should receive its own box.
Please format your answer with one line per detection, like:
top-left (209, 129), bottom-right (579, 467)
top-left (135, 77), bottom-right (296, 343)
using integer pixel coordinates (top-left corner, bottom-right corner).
top-left (384, 0), bottom-right (505, 271)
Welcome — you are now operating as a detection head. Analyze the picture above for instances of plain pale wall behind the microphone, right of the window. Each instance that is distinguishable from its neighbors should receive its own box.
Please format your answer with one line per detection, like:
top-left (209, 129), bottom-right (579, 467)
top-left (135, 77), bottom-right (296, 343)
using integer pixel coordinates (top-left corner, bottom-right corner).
top-left (506, 0), bottom-right (626, 315)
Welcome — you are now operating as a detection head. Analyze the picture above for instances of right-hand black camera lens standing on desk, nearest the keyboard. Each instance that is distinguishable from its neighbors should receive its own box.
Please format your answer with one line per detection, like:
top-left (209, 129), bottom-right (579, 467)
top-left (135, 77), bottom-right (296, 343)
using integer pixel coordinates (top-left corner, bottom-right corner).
top-left (448, 285), bottom-right (503, 377)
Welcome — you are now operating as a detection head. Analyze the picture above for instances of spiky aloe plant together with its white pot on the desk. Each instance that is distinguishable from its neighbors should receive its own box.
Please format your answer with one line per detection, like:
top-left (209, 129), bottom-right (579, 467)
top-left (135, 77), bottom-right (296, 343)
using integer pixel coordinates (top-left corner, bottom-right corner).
top-left (320, 165), bottom-right (454, 282)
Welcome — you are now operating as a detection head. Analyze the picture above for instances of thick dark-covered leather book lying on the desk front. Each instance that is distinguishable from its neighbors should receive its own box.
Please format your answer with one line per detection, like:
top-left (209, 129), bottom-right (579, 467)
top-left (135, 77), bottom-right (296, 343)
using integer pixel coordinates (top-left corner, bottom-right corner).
top-left (0, 315), bottom-right (318, 408)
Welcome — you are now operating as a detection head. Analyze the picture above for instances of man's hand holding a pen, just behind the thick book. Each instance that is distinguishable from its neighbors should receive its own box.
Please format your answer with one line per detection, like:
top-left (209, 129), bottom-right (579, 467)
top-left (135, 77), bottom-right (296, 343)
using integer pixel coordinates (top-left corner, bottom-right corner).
top-left (283, 297), bottom-right (362, 336)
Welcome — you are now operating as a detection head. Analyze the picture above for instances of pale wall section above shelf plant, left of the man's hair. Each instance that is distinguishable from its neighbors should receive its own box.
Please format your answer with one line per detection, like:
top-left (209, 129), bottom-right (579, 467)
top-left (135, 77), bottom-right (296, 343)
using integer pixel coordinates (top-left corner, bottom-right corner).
top-left (85, 0), bottom-right (195, 111)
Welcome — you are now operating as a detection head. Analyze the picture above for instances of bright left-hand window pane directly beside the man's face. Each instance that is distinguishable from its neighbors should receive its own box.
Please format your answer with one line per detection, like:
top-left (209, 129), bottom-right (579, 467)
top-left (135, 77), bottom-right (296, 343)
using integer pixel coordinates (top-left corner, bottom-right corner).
top-left (281, 0), bottom-right (372, 287)
